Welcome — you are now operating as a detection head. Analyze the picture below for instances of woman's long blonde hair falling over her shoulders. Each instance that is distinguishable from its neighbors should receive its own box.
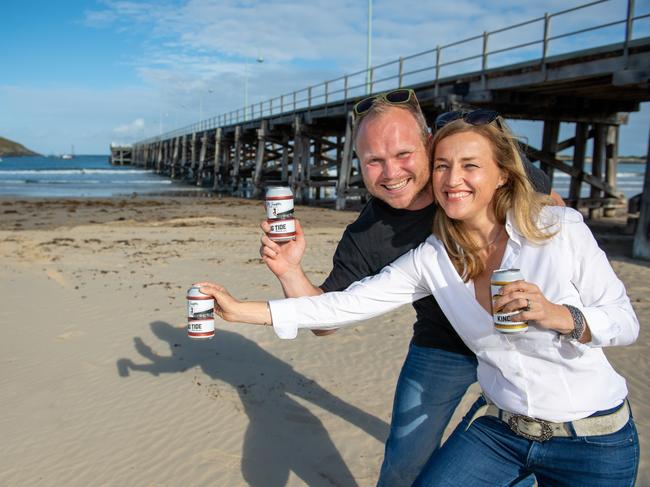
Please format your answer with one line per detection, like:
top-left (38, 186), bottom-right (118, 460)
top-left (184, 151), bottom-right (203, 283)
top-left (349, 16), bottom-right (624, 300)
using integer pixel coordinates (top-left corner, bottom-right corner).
top-left (430, 117), bottom-right (554, 281)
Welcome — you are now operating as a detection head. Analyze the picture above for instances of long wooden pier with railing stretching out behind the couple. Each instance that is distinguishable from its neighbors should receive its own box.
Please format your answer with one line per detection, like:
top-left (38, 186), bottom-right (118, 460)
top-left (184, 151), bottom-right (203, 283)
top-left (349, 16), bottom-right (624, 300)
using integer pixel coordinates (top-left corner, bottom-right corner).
top-left (116, 0), bottom-right (650, 258)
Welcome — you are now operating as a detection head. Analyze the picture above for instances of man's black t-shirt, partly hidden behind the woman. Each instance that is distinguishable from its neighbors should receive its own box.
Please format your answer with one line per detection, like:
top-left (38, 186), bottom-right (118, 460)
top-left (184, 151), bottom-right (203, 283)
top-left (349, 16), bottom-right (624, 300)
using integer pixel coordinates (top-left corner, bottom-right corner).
top-left (320, 164), bottom-right (551, 355)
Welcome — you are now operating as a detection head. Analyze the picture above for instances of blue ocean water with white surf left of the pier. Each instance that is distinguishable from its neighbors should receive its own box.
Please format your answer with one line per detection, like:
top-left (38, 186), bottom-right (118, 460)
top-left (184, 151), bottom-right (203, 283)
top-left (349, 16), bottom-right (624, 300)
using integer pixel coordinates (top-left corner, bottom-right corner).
top-left (0, 155), bottom-right (205, 198)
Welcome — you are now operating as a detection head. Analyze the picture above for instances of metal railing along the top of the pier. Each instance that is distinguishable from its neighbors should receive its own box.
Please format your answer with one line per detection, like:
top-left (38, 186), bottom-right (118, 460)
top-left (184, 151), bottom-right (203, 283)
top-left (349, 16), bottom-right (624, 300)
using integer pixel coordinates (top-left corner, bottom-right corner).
top-left (139, 0), bottom-right (650, 144)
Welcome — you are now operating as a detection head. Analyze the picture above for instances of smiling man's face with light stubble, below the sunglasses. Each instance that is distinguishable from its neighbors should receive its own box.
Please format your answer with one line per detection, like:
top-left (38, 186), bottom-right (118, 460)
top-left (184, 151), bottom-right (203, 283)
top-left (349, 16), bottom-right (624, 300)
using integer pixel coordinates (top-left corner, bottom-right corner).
top-left (356, 107), bottom-right (433, 210)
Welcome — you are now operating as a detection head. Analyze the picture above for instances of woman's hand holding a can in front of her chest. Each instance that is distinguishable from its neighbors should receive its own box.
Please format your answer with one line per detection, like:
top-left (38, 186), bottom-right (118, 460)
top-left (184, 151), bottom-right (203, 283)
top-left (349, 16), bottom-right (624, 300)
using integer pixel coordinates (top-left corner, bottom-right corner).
top-left (492, 281), bottom-right (574, 335)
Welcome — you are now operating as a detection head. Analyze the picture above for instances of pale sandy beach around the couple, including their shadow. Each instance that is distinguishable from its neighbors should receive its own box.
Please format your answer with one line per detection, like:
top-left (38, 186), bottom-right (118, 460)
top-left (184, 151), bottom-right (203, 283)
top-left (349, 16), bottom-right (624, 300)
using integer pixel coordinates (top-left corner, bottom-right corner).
top-left (0, 198), bottom-right (650, 487)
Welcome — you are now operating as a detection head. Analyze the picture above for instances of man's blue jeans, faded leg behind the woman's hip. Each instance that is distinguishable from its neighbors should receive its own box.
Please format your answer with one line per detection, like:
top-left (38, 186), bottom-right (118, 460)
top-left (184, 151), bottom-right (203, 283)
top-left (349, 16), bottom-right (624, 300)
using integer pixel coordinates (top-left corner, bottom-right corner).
top-left (377, 345), bottom-right (477, 487)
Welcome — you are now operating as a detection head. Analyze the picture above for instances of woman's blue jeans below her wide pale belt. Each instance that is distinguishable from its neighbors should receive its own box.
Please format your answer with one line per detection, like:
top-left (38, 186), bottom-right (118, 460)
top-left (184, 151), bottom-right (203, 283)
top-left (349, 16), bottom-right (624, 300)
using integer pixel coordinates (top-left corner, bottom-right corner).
top-left (414, 398), bottom-right (639, 487)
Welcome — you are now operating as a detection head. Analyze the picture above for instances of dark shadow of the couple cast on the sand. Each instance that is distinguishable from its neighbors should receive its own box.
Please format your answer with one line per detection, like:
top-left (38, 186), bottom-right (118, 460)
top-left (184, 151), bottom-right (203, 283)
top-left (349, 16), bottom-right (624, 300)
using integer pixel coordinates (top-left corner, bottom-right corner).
top-left (117, 321), bottom-right (388, 487)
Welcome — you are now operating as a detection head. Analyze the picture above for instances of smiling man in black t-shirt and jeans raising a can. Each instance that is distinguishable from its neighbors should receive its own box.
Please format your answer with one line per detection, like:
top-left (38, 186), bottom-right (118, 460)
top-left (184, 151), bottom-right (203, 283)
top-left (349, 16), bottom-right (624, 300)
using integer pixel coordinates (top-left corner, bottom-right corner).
top-left (260, 89), bottom-right (559, 486)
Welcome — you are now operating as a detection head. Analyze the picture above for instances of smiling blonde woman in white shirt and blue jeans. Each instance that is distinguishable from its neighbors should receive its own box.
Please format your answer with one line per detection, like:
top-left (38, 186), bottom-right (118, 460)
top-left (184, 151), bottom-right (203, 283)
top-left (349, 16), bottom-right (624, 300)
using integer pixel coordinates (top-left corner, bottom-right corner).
top-left (202, 110), bottom-right (639, 486)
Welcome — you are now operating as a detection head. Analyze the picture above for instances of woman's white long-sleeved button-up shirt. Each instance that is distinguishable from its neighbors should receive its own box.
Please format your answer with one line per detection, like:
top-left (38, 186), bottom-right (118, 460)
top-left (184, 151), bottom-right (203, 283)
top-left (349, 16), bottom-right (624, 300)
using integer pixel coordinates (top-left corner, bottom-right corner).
top-left (269, 207), bottom-right (639, 422)
